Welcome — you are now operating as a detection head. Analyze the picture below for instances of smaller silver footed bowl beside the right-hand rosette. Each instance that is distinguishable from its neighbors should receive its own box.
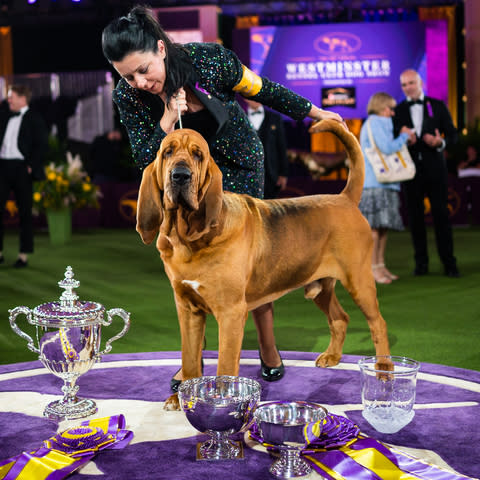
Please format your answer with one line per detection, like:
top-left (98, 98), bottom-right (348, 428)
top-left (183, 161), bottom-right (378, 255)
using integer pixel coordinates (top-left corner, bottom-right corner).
top-left (254, 401), bottom-right (328, 478)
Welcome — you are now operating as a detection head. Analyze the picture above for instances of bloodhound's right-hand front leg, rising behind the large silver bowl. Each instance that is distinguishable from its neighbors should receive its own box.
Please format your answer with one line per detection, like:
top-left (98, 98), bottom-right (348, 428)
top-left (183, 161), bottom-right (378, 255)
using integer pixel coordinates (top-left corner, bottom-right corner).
top-left (216, 305), bottom-right (248, 376)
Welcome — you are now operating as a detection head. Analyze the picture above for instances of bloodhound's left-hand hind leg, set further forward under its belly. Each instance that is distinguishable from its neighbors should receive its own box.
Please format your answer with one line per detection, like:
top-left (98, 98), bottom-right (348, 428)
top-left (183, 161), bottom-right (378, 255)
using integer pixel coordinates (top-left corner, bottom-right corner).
top-left (305, 278), bottom-right (349, 367)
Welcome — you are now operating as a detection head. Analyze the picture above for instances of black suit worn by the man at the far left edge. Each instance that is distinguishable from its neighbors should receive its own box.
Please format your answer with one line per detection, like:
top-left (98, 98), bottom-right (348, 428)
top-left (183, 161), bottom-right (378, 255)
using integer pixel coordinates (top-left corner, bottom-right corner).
top-left (0, 109), bottom-right (48, 253)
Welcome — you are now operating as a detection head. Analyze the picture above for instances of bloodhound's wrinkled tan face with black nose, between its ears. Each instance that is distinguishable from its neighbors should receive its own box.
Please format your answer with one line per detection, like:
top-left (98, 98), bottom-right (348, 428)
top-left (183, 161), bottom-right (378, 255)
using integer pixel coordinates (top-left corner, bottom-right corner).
top-left (160, 129), bottom-right (210, 210)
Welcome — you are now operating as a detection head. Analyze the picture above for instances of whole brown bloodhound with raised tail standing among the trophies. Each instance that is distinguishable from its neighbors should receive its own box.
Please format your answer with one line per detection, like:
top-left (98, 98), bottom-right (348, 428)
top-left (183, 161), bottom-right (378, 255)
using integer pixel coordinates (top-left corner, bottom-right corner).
top-left (137, 120), bottom-right (389, 409)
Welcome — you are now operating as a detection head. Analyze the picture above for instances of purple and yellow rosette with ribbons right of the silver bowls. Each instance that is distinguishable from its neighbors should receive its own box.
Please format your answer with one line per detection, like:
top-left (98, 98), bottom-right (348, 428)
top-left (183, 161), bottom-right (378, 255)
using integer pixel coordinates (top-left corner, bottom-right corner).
top-left (250, 413), bottom-right (471, 480)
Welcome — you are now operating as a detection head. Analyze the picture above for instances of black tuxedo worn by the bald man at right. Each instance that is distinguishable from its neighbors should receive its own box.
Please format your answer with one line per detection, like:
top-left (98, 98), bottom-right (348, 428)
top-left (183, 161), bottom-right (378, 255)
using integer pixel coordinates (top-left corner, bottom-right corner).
top-left (393, 97), bottom-right (457, 271)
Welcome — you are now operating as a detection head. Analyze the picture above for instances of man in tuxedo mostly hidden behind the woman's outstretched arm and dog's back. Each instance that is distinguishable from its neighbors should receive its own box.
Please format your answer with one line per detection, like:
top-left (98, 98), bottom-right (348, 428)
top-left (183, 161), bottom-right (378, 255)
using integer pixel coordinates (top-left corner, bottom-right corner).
top-left (245, 99), bottom-right (288, 198)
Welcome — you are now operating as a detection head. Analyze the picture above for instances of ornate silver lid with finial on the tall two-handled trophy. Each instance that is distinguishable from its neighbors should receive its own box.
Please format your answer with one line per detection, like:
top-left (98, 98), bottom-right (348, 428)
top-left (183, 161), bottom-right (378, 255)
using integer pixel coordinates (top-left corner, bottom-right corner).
top-left (30, 266), bottom-right (105, 327)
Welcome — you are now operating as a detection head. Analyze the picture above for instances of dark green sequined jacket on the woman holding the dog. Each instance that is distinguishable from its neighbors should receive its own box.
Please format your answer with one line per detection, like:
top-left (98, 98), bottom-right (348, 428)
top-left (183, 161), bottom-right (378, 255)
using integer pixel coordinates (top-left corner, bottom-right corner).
top-left (113, 43), bottom-right (312, 198)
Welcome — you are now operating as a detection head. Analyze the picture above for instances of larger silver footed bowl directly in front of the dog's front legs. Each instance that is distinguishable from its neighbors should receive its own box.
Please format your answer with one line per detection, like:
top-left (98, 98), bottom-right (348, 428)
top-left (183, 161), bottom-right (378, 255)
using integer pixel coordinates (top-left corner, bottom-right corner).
top-left (178, 376), bottom-right (261, 460)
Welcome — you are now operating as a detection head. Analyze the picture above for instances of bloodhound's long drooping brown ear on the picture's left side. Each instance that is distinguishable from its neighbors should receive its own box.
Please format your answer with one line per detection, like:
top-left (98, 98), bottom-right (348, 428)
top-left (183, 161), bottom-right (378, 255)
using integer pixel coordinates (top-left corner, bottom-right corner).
top-left (137, 159), bottom-right (163, 244)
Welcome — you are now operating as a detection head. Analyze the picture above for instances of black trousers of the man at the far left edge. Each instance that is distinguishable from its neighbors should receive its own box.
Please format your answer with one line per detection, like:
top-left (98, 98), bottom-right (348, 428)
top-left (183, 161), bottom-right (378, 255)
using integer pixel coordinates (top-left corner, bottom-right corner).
top-left (0, 159), bottom-right (33, 253)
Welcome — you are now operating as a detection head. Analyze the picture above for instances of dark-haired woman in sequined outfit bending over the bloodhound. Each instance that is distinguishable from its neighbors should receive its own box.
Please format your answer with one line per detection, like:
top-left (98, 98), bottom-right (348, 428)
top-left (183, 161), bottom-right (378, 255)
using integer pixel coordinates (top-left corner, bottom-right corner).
top-left (102, 6), bottom-right (343, 391)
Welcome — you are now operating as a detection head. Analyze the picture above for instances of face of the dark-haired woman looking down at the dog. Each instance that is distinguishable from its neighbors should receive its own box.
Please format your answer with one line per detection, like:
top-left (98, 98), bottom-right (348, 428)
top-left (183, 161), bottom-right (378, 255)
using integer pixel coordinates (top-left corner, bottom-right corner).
top-left (112, 40), bottom-right (166, 95)
